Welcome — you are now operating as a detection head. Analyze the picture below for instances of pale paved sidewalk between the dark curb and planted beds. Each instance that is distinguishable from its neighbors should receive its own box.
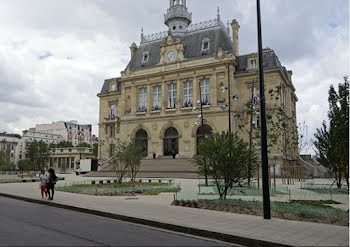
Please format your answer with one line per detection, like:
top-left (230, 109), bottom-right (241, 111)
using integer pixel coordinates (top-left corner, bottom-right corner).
top-left (0, 183), bottom-right (349, 246)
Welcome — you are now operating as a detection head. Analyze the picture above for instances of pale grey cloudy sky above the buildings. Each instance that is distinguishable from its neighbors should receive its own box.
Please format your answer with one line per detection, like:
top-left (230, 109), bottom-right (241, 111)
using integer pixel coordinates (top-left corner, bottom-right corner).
top-left (0, 0), bottom-right (349, 147)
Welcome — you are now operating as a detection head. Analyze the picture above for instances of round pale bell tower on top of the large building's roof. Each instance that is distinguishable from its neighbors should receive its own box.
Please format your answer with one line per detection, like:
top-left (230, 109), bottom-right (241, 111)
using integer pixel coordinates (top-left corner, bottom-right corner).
top-left (164, 0), bottom-right (192, 36)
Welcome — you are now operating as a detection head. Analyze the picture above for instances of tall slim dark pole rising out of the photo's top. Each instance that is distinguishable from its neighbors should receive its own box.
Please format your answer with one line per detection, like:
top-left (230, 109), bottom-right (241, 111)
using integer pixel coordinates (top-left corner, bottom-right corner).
top-left (256, 0), bottom-right (271, 219)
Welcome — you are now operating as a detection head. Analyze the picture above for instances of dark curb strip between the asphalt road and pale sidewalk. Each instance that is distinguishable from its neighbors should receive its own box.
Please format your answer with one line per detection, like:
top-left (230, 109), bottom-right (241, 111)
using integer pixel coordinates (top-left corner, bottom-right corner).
top-left (0, 193), bottom-right (292, 247)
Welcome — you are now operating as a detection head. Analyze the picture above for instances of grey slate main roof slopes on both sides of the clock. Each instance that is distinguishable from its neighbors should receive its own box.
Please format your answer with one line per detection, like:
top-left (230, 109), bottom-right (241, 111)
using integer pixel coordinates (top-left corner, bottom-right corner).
top-left (128, 26), bottom-right (233, 70)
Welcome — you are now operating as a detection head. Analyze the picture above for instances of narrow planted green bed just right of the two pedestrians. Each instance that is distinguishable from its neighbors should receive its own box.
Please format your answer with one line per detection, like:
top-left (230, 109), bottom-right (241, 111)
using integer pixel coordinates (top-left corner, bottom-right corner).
top-left (57, 182), bottom-right (180, 196)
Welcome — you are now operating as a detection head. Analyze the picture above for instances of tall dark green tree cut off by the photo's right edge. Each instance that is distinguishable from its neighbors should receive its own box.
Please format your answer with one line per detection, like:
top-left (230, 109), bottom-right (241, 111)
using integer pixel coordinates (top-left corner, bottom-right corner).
top-left (314, 77), bottom-right (349, 188)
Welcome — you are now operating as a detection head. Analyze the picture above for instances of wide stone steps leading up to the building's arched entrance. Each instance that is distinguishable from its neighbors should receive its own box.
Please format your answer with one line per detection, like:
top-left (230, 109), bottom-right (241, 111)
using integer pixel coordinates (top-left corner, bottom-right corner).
top-left (86, 157), bottom-right (199, 178)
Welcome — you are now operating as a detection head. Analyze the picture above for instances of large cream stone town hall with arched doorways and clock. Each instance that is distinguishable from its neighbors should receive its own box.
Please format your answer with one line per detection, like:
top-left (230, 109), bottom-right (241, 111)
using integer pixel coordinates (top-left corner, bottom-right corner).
top-left (98, 0), bottom-right (297, 166)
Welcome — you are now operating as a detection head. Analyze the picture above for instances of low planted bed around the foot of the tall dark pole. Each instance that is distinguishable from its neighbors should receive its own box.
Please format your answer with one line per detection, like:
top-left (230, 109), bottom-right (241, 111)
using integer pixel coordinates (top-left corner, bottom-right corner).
top-left (173, 199), bottom-right (349, 226)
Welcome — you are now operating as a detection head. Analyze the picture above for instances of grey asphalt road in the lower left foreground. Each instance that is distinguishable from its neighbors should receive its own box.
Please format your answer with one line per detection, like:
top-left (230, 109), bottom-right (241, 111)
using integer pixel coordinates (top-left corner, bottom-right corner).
top-left (0, 197), bottom-right (232, 246)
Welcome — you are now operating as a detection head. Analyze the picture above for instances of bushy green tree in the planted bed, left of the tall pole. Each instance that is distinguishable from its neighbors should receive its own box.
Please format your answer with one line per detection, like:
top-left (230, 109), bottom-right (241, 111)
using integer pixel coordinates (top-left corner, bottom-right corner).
top-left (197, 132), bottom-right (256, 200)
